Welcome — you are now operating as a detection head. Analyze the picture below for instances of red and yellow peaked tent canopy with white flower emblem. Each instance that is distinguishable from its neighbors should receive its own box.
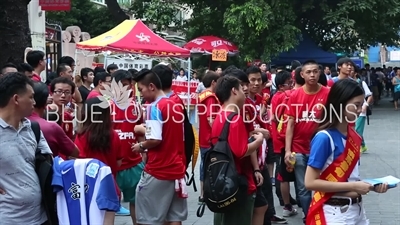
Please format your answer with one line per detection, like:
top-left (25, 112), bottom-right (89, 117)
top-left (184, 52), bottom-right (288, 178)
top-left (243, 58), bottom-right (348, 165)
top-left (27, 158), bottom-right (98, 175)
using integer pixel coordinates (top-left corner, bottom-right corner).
top-left (76, 20), bottom-right (190, 57)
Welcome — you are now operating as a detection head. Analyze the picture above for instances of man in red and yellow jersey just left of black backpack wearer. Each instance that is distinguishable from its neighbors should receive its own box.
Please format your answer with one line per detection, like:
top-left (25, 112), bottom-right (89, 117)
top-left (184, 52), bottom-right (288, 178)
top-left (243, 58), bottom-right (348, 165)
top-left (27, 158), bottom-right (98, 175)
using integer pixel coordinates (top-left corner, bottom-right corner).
top-left (197, 71), bottom-right (220, 204)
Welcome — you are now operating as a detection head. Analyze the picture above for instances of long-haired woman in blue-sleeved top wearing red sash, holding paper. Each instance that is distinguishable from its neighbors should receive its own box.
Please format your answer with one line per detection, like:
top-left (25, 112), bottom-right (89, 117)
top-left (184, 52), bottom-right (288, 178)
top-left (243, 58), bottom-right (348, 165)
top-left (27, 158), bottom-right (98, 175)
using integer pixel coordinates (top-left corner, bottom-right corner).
top-left (305, 79), bottom-right (388, 225)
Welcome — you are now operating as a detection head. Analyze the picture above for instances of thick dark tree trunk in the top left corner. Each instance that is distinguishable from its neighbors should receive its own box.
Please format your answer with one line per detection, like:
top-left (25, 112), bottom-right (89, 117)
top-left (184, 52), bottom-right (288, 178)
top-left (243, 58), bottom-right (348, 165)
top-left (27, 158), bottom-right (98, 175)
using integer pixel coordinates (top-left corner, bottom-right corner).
top-left (0, 0), bottom-right (32, 65)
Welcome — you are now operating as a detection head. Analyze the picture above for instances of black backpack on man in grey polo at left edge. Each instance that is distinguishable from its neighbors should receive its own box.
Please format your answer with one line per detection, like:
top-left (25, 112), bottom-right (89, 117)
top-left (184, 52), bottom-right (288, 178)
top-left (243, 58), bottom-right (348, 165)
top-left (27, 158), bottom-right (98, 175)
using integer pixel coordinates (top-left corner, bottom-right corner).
top-left (31, 121), bottom-right (59, 225)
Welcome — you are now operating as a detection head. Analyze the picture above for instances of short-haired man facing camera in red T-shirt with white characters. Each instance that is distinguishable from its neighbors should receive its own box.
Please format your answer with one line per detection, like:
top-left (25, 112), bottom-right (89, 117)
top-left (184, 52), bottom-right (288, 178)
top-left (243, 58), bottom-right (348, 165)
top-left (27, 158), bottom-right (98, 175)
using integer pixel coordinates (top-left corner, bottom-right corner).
top-left (285, 60), bottom-right (329, 221)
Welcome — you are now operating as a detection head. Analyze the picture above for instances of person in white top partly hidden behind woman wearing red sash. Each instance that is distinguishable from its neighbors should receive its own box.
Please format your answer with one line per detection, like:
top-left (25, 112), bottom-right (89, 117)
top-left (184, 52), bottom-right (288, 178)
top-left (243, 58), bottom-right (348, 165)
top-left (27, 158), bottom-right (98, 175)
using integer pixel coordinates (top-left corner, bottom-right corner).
top-left (350, 67), bottom-right (374, 153)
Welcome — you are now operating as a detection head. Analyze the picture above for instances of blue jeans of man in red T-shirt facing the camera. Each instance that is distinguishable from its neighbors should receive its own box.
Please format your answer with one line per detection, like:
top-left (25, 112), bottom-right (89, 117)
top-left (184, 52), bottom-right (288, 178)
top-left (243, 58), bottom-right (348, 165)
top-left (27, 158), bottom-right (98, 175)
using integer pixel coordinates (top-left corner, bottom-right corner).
top-left (294, 153), bottom-right (311, 216)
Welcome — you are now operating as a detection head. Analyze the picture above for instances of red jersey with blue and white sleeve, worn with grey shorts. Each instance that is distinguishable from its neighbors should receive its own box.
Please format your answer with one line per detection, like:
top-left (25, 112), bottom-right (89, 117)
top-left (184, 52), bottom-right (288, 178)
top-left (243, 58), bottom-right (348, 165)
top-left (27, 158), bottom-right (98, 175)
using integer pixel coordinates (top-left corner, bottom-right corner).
top-left (144, 96), bottom-right (186, 180)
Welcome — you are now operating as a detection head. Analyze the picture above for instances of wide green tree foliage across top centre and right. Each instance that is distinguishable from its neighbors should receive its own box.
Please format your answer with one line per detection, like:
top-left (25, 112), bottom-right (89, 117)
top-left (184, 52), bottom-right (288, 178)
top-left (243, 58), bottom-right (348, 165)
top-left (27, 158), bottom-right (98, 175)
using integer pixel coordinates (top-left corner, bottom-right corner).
top-left (104, 0), bottom-right (400, 60)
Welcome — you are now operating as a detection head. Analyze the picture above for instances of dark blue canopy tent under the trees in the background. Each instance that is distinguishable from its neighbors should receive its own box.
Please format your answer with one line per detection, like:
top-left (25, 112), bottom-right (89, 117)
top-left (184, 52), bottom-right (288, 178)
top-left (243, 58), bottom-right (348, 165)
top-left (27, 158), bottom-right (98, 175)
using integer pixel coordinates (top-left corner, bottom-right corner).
top-left (271, 35), bottom-right (337, 65)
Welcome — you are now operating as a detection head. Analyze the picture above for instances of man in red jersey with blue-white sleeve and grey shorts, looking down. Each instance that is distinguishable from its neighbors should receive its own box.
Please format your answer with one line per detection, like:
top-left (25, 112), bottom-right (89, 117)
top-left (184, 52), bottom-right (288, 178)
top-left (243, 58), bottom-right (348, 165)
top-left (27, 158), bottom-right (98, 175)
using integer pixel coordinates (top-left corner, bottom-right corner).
top-left (132, 70), bottom-right (188, 224)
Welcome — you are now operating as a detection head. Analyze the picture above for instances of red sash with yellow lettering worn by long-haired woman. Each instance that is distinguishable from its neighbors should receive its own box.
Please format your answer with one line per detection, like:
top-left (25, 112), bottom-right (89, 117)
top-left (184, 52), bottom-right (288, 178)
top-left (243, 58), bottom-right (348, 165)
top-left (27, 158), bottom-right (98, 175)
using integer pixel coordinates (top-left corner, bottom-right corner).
top-left (306, 126), bottom-right (361, 225)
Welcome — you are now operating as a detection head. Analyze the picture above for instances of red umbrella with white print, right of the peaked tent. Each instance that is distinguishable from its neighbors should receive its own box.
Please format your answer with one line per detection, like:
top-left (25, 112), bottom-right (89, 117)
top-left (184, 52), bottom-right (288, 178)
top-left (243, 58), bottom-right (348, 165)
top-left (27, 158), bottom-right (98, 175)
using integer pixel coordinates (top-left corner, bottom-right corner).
top-left (183, 36), bottom-right (239, 55)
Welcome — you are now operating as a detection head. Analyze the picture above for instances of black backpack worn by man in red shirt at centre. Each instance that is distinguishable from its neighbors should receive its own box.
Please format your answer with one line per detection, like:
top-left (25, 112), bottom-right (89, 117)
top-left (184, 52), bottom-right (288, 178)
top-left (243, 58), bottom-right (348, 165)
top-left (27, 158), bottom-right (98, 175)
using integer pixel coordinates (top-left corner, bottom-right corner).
top-left (203, 113), bottom-right (248, 213)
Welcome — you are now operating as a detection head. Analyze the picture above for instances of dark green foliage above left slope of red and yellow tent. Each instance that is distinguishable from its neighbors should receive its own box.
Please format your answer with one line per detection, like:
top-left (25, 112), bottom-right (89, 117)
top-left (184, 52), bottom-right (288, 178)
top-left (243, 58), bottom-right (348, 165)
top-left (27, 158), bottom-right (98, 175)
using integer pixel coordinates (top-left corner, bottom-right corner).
top-left (46, 0), bottom-right (120, 37)
